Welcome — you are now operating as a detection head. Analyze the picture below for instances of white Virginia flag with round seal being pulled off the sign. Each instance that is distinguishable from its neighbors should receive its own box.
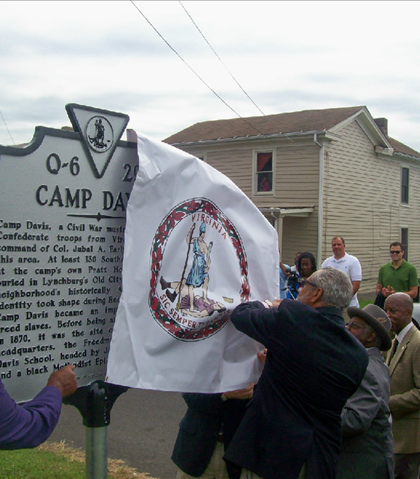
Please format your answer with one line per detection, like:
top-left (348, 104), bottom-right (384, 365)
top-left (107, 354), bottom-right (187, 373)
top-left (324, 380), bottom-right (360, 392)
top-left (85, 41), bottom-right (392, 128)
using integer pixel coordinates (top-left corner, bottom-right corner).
top-left (107, 135), bottom-right (279, 393)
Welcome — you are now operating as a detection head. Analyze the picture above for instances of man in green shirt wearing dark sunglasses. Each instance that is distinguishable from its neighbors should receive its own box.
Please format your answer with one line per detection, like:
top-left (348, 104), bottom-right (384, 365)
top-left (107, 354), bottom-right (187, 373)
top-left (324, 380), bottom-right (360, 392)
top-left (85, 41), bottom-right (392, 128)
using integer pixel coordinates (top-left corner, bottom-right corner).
top-left (376, 241), bottom-right (418, 299)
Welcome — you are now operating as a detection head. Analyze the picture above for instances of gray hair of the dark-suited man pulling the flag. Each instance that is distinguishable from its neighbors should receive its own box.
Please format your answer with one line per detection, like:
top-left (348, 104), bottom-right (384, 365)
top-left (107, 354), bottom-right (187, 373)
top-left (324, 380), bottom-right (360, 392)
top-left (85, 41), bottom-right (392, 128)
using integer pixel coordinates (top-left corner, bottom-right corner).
top-left (309, 268), bottom-right (353, 311)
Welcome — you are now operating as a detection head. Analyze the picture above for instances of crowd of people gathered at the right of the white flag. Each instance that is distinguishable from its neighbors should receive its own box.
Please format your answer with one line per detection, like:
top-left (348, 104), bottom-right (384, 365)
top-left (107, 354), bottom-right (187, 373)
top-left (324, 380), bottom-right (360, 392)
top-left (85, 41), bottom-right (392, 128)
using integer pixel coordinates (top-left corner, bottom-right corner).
top-left (172, 236), bottom-right (420, 479)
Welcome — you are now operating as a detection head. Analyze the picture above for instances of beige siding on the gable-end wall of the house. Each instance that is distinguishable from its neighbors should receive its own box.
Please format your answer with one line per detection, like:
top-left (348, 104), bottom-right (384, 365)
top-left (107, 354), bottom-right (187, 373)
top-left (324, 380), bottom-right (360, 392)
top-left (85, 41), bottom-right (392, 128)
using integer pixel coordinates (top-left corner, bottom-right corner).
top-left (322, 122), bottom-right (420, 292)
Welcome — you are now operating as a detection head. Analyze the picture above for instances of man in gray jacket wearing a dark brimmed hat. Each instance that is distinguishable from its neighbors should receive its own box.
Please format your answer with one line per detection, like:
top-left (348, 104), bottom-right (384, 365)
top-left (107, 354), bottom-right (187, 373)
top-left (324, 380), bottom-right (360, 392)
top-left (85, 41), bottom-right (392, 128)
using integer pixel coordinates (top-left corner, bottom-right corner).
top-left (337, 304), bottom-right (394, 479)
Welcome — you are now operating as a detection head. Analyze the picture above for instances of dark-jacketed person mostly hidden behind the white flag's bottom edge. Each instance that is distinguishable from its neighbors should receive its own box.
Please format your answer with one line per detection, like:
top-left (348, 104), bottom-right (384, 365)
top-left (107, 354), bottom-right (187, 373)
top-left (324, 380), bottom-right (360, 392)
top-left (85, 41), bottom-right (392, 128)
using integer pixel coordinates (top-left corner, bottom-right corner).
top-left (172, 384), bottom-right (254, 479)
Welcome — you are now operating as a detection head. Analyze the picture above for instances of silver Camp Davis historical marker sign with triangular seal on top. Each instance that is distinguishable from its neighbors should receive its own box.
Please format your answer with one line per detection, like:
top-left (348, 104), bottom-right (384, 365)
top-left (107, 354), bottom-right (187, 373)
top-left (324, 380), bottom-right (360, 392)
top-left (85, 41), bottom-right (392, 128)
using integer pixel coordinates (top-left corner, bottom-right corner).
top-left (0, 104), bottom-right (138, 400)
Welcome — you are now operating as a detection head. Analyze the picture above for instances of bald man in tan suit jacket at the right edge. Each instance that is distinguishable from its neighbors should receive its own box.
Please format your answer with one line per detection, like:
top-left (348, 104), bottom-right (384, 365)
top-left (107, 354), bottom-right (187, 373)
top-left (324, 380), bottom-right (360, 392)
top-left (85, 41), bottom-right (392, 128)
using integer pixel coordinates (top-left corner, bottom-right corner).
top-left (385, 293), bottom-right (420, 479)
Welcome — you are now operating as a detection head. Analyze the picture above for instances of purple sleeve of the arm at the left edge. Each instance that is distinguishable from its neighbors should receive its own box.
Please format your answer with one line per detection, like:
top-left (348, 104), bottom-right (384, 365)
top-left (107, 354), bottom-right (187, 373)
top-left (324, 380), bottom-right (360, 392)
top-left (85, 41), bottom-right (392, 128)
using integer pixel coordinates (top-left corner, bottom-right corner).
top-left (0, 381), bottom-right (62, 449)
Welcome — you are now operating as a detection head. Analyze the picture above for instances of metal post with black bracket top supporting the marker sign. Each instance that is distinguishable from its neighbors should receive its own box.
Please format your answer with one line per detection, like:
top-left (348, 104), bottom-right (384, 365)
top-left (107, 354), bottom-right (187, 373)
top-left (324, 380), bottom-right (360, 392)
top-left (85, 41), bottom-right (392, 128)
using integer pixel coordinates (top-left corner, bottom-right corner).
top-left (65, 381), bottom-right (128, 479)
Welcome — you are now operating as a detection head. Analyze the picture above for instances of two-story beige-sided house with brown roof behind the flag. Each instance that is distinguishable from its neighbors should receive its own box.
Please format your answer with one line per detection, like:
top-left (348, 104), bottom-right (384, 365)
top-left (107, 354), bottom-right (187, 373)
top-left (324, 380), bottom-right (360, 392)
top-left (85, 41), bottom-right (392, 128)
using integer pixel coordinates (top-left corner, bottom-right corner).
top-left (164, 106), bottom-right (420, 293)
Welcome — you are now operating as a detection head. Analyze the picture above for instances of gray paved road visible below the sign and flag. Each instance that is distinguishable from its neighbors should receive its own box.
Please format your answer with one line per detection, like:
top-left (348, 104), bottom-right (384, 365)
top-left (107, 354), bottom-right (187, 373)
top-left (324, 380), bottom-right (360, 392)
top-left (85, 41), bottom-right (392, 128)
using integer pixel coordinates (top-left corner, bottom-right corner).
top-left (50, 389), bottom-right (186, 479)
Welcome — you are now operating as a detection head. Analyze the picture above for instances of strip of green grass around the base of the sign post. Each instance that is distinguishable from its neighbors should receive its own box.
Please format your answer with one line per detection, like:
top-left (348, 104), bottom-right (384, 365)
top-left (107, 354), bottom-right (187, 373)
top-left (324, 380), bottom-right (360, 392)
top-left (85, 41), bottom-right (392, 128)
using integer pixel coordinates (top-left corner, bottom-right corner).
top-left (0, 441), bottom-right (154, 479)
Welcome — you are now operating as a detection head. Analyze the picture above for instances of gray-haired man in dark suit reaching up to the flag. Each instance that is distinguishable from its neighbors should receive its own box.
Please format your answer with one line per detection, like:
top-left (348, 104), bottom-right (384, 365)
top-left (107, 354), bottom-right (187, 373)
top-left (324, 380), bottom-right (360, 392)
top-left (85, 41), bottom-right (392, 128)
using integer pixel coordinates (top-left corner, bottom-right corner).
top-left (225, 268), bottom-right (368, 479)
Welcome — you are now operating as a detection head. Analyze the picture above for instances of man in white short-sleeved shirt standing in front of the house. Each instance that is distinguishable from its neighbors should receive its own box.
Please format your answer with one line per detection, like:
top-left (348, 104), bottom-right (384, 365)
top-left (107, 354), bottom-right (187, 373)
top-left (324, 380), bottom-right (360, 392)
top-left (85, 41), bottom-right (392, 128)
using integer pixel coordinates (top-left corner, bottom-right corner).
top-left (321, 236), bottom-right (362, 308)
